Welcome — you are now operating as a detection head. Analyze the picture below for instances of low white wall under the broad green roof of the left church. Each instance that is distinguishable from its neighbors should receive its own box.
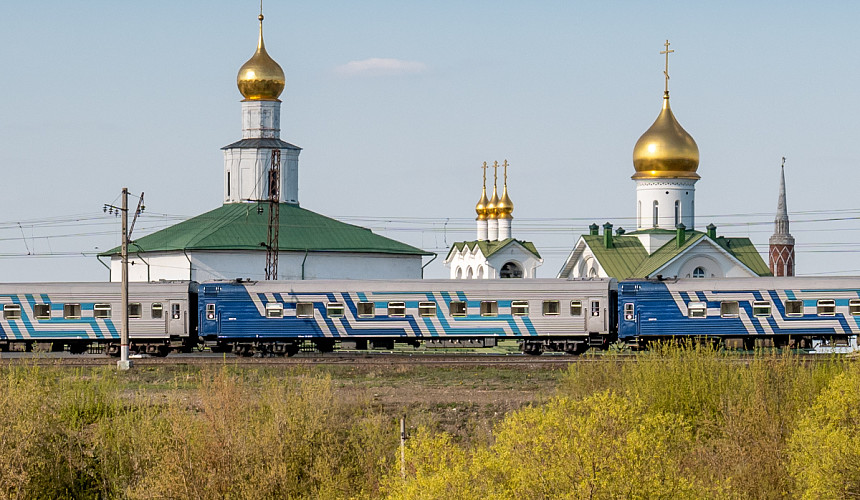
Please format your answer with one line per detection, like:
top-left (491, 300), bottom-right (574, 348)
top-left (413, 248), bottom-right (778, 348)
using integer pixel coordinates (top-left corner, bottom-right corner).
top-left (110, 250), bottom-right (422, 281)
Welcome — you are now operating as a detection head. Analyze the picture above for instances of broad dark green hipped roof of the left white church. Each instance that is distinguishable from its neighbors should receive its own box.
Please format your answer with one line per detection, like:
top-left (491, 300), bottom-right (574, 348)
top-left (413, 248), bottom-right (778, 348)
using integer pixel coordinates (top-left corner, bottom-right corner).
top-left (99, 203), bottom-right (433, 256)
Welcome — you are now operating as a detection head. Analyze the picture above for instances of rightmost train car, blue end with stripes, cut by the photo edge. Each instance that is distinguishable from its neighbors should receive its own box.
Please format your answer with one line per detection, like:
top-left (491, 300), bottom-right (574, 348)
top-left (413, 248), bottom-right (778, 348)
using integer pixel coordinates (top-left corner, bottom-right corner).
top-left (618, 277), bottom-right (860, 349)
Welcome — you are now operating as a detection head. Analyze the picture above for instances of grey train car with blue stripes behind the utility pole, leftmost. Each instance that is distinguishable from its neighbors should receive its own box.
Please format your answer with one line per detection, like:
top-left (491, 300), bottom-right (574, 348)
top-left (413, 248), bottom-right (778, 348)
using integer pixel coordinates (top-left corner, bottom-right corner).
top-left (0, 281), bottom-right (197, 355)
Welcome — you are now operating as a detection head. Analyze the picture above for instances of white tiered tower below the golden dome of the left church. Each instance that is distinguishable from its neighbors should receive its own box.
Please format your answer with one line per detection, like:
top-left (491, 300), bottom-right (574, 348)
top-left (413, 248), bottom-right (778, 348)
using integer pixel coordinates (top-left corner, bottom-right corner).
top-left (224, 100), bottom-right (301, 205)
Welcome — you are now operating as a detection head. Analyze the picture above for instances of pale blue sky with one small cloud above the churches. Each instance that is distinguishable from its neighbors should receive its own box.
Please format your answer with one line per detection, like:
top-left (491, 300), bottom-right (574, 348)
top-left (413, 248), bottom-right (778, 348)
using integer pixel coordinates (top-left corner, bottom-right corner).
top-left (0, 0), bottom-right (860, 282)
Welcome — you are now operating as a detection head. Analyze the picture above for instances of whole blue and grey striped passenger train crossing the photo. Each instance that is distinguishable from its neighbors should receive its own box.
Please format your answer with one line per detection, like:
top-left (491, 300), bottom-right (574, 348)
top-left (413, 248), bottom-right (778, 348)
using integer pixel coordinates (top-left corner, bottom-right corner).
top-left (0, 277), bottom-right (860, 356)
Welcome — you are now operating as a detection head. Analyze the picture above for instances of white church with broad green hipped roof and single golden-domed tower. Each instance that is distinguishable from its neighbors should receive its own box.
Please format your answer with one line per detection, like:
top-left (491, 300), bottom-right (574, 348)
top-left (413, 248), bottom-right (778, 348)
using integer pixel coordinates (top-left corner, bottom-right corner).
top-left (99, 13), bottom-right (433, 281)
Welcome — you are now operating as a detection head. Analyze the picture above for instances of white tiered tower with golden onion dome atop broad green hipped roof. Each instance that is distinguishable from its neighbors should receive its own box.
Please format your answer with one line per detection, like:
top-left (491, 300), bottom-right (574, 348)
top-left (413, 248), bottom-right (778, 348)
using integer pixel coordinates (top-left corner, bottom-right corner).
top-left (221, 12), bottom-right (301, 205)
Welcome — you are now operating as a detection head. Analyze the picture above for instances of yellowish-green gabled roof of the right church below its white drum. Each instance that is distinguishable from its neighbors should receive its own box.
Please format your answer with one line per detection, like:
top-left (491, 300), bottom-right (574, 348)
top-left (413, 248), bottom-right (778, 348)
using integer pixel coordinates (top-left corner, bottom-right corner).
top-left (582, 229), bottom-right (770, 280)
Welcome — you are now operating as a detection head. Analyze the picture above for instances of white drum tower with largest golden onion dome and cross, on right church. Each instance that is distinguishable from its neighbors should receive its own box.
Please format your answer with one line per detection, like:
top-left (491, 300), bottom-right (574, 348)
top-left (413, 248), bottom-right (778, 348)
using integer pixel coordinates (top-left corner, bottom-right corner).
top-left (632, 40), bottom-right (699, 231)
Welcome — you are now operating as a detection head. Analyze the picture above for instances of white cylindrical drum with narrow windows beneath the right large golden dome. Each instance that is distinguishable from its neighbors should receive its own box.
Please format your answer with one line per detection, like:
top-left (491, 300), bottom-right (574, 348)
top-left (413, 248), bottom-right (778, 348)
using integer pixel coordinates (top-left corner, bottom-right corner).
top-left (636, 178), bottom-right (697, 230)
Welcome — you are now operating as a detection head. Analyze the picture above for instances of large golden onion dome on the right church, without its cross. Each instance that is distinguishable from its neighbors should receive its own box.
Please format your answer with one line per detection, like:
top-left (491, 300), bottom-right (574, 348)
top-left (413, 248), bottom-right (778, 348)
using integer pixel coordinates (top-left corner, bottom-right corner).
top-left (633, 91), bottom-right (699, 179)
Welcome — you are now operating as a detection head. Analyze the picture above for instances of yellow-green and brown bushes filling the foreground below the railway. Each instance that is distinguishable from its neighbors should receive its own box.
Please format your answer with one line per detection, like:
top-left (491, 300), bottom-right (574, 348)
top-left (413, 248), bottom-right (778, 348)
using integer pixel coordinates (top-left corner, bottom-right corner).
top-left (0, 346), bottom-right (860, 500)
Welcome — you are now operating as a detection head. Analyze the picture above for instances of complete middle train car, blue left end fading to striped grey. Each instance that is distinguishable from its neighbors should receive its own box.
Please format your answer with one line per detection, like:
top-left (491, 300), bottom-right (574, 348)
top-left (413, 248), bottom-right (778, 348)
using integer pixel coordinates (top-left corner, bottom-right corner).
top-left (198, 279), bottom-right (617, 355)
